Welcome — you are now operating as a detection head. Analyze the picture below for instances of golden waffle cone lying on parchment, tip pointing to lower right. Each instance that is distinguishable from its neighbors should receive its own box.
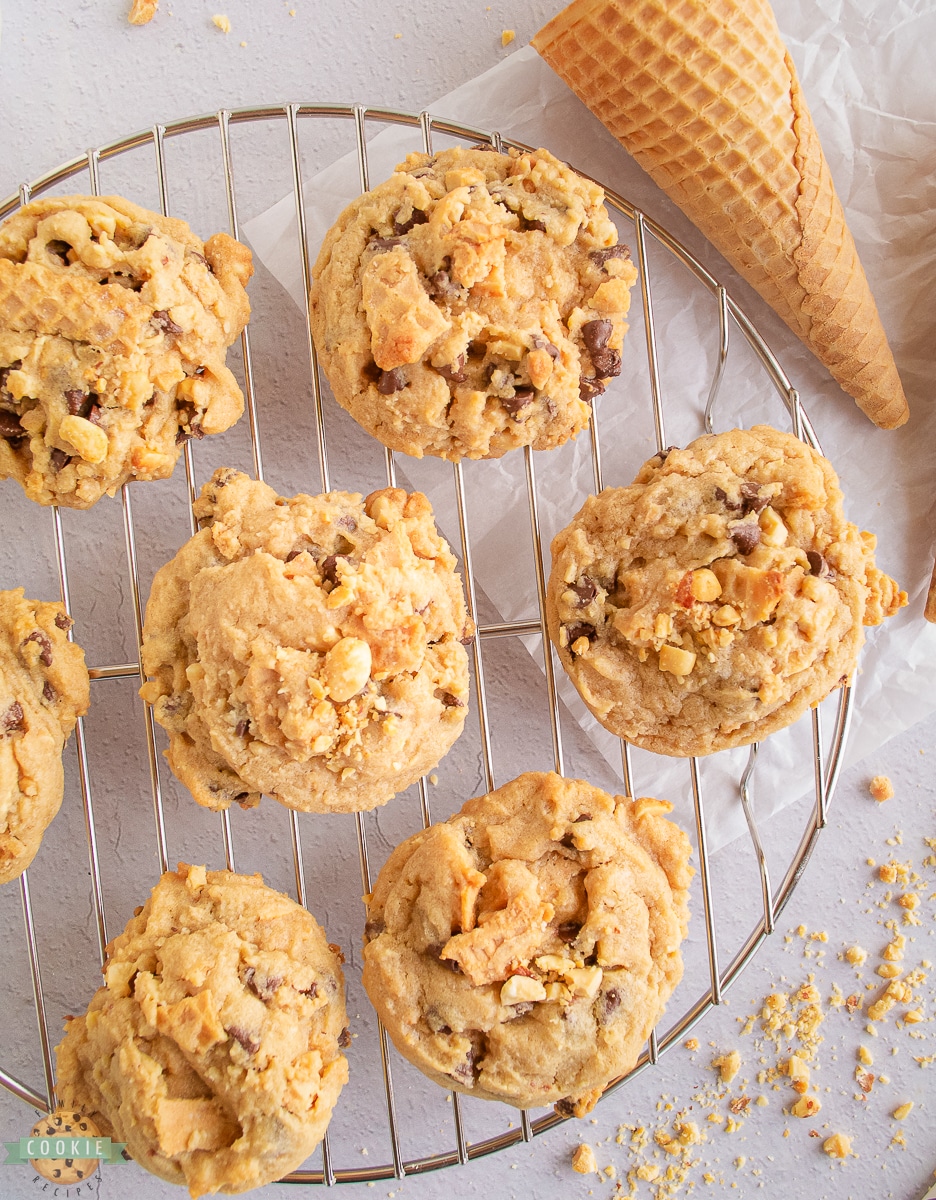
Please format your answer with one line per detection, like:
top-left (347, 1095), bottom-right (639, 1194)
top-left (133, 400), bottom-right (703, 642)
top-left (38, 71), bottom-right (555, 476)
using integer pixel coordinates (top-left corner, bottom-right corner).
top-left (533, 0), bottom-right (908, 428)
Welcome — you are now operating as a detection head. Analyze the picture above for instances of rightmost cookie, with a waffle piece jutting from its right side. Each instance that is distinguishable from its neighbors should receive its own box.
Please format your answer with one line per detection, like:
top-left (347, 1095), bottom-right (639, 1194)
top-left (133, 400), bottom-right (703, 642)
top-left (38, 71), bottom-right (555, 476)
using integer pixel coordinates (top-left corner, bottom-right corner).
top-left (546, 425), bottom-right (907, 755)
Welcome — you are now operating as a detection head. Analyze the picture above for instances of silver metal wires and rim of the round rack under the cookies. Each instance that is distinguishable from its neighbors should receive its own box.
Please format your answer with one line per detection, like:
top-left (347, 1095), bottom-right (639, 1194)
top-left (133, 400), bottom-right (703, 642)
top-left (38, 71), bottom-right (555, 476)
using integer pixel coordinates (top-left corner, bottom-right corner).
top-left (0, 104), bottom-right (852, 1184)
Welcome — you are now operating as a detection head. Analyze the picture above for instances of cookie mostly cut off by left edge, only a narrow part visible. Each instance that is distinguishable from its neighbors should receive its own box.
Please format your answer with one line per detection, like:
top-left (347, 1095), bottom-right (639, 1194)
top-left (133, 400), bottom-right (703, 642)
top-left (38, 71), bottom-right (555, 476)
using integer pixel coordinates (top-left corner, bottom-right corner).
top-left (0, 588), bottom-right (90, 883)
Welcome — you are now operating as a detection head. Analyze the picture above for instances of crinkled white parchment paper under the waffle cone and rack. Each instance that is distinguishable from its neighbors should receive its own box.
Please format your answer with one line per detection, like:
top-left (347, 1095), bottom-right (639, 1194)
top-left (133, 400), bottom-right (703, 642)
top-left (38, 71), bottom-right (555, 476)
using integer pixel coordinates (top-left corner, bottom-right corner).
top-left (244, 11), bottom-right (936, 846)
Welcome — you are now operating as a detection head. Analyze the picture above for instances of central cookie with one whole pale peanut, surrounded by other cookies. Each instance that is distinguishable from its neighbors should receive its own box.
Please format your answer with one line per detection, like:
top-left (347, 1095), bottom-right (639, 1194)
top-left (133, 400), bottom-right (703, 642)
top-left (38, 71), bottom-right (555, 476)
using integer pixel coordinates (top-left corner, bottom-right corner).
top-left (140, 469), bottom-right (473, 812)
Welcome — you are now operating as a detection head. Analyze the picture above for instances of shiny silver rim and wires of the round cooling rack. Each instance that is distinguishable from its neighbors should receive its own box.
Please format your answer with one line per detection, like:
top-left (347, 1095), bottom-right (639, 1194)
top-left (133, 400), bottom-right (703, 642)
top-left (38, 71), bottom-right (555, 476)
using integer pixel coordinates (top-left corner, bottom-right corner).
top-left (0, 103), bottom-right (853, 1186)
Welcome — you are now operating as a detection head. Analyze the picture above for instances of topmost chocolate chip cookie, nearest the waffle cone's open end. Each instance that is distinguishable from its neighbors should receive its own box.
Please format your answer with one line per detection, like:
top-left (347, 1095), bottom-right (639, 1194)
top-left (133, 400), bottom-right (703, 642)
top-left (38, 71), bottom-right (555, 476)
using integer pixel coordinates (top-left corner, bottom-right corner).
top-left (311, 141), bottom-right (636, 461)
